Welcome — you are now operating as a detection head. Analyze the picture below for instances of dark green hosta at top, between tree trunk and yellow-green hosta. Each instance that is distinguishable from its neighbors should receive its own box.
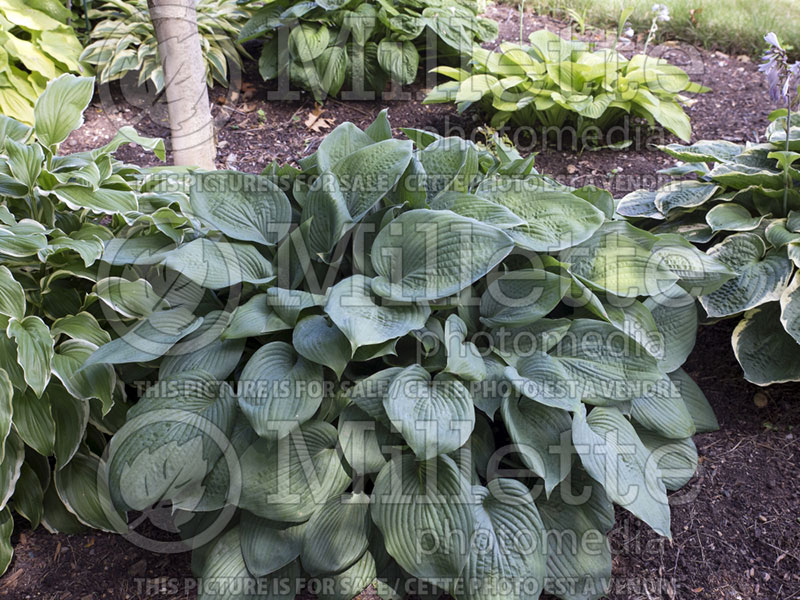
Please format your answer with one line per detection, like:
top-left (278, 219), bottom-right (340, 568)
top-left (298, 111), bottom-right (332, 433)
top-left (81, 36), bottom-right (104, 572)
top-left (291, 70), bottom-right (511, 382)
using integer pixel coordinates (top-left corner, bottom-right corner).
top-left (240, 0), bottom-right (497, 100)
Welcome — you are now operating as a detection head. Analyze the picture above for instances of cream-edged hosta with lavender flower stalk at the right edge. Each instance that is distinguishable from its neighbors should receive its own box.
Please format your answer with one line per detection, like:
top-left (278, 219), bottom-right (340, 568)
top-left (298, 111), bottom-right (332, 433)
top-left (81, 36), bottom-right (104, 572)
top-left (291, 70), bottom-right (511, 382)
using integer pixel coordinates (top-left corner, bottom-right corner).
top-left (618, 116), bottom-right (800, 385)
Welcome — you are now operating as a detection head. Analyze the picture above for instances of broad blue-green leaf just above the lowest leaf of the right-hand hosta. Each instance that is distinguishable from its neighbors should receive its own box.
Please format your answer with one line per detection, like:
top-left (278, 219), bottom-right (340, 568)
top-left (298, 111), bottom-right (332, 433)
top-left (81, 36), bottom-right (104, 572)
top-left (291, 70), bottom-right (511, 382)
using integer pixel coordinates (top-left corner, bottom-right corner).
top-left (700, 233), bottom-right (792, 317)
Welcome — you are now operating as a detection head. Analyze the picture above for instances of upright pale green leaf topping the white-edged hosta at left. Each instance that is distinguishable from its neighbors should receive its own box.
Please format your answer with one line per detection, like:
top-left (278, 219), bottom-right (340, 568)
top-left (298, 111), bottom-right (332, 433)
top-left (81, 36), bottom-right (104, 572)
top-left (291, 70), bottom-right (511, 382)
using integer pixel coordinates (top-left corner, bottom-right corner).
top-left (33, 74), bottom-right (94, 147)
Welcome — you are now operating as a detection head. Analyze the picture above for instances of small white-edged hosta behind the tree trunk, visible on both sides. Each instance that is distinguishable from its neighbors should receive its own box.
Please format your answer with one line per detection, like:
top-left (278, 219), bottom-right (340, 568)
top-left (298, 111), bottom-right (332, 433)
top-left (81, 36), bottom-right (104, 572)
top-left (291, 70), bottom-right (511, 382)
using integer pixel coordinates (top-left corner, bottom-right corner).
top-left (81, 0), bottom-right (252, 93)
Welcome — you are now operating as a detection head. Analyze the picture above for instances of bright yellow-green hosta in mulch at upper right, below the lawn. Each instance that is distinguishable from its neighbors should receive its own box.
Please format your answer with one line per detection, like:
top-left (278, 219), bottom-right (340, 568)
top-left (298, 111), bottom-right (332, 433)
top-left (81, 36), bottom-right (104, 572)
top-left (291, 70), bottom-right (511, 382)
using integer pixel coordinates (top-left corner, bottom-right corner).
top-left (425, 30), bottom-right (708, 142)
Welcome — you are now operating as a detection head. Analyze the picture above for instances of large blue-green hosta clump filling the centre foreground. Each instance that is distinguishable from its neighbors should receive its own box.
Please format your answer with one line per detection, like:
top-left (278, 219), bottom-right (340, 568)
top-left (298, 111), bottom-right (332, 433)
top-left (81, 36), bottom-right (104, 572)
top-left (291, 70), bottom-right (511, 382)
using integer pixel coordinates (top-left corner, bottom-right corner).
top-left (97, 114), bottom-right (728, 599)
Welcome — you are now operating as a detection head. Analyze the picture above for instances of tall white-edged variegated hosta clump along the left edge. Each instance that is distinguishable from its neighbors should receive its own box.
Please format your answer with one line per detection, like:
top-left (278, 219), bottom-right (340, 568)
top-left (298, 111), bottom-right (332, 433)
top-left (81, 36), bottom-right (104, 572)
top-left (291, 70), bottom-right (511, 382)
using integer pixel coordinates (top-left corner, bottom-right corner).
top-left (0, 75), bottom-right (185, 573)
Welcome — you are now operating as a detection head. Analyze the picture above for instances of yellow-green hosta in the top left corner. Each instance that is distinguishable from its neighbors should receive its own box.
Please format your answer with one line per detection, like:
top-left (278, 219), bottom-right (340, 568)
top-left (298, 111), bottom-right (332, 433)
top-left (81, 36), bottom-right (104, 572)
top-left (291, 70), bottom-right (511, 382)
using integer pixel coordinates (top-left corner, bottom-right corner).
top-left (0, 0), bottom-right (84, 125)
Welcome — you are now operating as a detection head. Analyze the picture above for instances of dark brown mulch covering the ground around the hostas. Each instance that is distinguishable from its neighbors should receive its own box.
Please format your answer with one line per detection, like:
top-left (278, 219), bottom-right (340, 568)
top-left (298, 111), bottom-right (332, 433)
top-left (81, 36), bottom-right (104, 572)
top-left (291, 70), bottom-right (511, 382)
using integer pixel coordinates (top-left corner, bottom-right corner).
top-left (0, 6), bottom-right (800, 600)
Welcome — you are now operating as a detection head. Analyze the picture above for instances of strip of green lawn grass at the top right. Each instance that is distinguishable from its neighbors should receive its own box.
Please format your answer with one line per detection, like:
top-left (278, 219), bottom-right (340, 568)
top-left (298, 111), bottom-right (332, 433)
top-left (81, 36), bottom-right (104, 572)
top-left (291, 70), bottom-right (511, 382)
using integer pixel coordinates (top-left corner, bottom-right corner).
top-left (499, 0), bottom-right (800, 56)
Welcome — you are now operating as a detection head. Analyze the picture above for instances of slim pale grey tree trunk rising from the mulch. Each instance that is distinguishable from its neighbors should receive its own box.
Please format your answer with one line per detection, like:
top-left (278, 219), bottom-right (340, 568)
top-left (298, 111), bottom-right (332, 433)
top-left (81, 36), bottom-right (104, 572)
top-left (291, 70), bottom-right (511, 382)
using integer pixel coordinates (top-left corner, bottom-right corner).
top-left (147, 0), bottom-right (216, 169)
